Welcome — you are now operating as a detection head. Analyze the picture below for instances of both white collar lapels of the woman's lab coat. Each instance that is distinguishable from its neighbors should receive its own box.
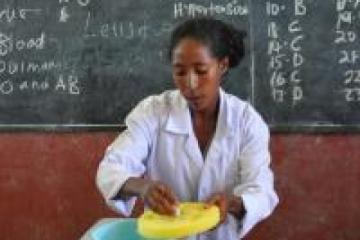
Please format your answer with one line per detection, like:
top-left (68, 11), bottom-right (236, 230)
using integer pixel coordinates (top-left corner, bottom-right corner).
top-left (165, 88), bottom-right (234, 136)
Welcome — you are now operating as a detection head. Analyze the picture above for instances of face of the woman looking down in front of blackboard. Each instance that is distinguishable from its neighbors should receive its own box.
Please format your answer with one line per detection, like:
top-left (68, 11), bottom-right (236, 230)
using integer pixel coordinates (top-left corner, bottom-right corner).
top-left (172, 38), bottom-right (228, 112)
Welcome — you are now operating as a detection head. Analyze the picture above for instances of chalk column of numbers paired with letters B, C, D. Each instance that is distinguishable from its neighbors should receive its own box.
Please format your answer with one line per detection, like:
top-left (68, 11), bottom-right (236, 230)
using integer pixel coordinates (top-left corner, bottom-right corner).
top-left (266, 1), bottom-right (307, 104)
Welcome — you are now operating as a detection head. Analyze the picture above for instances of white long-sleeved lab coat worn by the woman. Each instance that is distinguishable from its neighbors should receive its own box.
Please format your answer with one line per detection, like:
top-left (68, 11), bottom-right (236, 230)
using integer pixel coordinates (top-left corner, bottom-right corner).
top-left (97, 89), bottom-right (278, 240)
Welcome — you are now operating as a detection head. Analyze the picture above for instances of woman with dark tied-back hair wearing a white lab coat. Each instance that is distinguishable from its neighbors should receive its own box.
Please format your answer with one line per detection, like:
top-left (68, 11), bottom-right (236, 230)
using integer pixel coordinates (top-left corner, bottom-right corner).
top-left (97, 19), bottom-right (278, 240)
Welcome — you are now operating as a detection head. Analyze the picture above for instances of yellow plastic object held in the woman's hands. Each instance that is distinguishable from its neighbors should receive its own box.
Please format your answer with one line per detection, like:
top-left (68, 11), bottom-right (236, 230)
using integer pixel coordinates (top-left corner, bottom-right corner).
top-left (138, 202), bottom-right (220, 239)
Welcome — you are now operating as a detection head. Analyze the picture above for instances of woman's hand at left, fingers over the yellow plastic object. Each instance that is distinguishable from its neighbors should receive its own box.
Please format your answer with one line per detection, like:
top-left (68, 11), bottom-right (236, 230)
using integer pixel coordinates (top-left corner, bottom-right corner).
top-left (141, 181), bottom-right (178, 216)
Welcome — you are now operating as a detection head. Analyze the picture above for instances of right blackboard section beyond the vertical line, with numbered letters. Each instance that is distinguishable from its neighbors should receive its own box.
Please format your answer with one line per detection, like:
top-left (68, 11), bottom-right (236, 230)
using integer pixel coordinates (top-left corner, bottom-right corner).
top-left (251, 0), bottom-right (360, 131)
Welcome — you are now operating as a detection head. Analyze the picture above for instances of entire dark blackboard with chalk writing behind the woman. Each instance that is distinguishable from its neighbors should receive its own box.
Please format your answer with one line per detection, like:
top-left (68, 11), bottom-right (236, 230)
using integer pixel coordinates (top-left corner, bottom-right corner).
top-left (0, 0), bottom-right (360, 131)
